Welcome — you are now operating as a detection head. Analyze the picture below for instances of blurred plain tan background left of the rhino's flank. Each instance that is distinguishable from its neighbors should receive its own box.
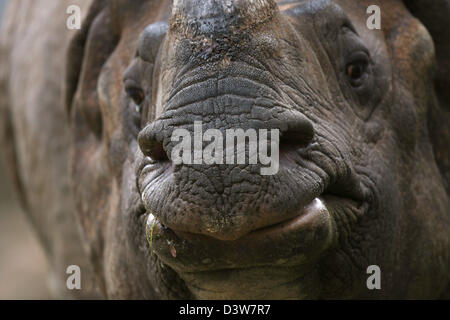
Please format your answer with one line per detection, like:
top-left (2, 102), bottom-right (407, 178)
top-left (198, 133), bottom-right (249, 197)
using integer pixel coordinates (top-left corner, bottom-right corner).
top-left (0, 0), bottom-right (50, 299)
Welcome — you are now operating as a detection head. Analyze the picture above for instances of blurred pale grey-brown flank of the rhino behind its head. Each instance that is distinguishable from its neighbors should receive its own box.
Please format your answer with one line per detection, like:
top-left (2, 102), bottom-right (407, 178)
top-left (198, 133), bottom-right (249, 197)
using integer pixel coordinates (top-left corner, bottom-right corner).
top-left (0, 0), bottom-right (97, 297)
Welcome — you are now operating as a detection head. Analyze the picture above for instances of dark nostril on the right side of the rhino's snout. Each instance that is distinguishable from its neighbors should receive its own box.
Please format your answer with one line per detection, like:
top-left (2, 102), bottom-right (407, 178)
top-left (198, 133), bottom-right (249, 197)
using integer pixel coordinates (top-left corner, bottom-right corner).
top-left (280, 117), bottom-right (314, 149)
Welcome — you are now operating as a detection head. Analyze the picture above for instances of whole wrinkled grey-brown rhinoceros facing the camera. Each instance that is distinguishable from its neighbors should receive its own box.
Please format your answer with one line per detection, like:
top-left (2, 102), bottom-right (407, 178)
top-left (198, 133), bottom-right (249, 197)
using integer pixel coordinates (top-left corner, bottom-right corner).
top-left (0, 0), bottom-right (450, 299)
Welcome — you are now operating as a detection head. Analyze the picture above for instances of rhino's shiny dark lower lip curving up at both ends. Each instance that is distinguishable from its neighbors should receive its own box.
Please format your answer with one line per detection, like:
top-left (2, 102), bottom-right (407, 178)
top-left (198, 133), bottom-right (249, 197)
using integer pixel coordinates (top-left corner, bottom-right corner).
top-left (142, 198), bottom-right (335, 272)
